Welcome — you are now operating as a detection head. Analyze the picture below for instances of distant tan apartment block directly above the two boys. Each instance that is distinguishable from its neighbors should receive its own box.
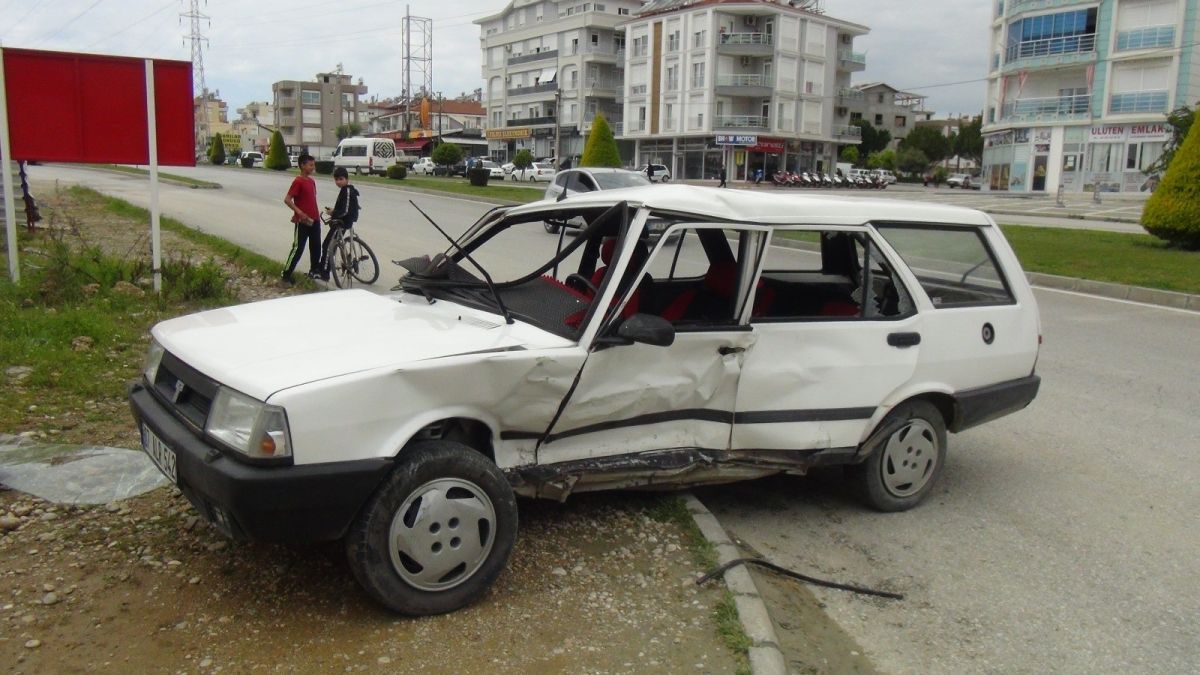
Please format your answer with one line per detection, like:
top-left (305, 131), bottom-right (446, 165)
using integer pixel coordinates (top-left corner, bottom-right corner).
top-left (271, 73), bottom-right (367, 156)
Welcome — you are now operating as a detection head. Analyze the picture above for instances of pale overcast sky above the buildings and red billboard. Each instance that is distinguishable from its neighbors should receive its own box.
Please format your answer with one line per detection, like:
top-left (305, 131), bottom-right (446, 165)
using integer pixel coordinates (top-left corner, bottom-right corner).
top-left (0, 0), bottom-right (990, 117)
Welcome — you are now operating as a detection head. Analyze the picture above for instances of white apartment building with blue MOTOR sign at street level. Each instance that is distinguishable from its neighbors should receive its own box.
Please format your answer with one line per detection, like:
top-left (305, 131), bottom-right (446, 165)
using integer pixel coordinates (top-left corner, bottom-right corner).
top-left (622, 0), bottom-right (868, 179)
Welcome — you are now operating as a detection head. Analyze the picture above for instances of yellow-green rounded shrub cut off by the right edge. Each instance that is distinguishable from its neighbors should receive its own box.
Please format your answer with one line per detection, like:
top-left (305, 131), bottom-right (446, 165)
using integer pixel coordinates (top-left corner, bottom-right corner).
top-left (1141, 114), bottom-right (1200, 251)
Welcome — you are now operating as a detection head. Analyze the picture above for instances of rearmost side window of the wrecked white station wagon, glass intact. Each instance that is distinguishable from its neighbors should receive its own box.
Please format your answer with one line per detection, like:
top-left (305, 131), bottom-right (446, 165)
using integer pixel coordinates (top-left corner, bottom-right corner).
top-left (876, 225), bottom-right (1014, 307)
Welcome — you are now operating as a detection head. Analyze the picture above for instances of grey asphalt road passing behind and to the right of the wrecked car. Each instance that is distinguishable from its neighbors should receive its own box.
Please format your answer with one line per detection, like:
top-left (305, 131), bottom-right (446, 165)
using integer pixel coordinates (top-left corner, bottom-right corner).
top-left (34, 167), bottom-right (1200, 673)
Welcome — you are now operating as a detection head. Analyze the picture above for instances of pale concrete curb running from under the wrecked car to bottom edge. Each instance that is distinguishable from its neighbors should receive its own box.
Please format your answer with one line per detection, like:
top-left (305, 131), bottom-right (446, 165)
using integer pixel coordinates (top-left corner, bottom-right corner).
top-left (684, 492), bottom-right (787, 675)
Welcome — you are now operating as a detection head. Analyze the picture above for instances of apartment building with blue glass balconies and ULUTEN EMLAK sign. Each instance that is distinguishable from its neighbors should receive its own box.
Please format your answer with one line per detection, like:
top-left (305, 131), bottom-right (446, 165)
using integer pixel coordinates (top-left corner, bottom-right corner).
top-left (983, 0), bottom-right (1200, 193)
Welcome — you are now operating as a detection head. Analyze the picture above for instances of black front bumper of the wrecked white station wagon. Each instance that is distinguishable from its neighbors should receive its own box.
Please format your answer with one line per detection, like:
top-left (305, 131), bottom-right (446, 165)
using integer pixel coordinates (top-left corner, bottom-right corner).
top-left (130, 382), bottom-right (392, 543)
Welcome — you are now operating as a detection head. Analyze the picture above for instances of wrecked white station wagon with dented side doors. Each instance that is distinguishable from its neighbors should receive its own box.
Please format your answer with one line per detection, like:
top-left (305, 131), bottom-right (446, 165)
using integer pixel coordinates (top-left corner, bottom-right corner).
top-left (131, 185), bottom-right (1040, 615)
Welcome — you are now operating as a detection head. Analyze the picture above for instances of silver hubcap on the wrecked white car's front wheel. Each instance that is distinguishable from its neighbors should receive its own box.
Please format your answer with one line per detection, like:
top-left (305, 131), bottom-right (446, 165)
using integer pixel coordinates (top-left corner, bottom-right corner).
top-left (388, 478), bottom-right (496, 591)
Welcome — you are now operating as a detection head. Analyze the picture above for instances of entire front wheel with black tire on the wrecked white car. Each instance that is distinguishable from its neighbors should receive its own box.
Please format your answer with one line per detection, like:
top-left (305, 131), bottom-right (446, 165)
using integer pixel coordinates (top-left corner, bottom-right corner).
top-left (346, 441), bottom-right (517, 616)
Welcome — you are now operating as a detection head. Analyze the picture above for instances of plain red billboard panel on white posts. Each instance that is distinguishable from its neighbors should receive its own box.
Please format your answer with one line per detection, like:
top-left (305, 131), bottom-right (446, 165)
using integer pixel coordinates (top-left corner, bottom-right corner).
top-left (4, 48), bottom-right (196, 166)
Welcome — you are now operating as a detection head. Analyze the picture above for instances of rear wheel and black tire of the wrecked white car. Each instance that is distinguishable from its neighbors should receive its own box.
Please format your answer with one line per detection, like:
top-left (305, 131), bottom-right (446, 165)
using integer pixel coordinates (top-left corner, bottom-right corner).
top-left (851, 401), bottom-right (946, 512)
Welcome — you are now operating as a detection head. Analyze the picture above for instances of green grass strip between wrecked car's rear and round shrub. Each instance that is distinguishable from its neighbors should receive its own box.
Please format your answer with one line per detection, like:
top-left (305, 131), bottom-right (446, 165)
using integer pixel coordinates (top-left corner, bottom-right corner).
top-left (1001, 225), bottom-right (1200, 293)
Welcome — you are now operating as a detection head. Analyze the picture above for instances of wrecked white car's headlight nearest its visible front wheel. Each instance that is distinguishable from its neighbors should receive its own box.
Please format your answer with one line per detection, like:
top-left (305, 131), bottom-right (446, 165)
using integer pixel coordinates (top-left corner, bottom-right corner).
top-left (204, 387), bottom-right (292, 459)
